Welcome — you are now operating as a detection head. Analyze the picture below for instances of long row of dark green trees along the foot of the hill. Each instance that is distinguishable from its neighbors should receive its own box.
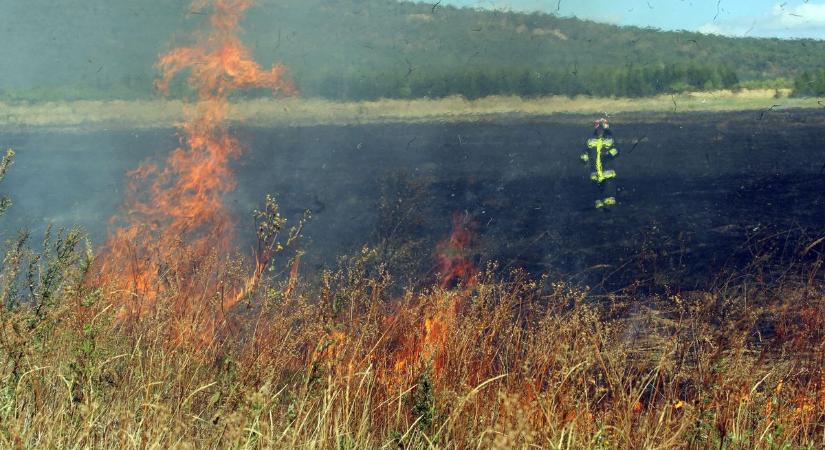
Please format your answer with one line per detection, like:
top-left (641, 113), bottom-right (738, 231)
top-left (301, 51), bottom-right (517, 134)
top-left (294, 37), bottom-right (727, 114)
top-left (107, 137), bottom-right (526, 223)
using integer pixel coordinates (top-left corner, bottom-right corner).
top-left (300, 63), bottom-right (739, 101)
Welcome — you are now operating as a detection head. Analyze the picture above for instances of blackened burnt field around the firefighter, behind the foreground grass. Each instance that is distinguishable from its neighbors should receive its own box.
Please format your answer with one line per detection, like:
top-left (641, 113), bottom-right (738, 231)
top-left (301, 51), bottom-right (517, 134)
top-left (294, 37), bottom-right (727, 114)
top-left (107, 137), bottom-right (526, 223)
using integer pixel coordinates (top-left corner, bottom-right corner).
top-left (2, 111), bottom-right (825, 289)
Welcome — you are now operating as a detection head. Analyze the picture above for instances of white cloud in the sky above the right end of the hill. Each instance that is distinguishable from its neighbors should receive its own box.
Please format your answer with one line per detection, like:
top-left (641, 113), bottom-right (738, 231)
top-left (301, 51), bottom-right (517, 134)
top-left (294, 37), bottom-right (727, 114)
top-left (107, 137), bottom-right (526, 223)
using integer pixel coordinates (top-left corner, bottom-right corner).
top-left (698, 2), bottom-right (825, 39)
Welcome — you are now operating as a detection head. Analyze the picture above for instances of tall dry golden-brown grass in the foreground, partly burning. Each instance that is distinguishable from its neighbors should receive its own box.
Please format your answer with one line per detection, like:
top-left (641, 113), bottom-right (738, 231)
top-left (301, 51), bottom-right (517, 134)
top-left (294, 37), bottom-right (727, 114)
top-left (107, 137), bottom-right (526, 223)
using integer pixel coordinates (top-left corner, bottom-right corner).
top-left (0, 234), bottom-right (825, 449)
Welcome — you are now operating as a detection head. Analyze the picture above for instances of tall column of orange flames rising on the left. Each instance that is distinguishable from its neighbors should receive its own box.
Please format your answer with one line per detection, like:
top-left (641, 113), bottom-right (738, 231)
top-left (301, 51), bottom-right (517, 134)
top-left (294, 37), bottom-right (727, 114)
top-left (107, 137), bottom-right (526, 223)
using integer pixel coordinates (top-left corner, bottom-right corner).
top-left (100, 0), bottom-right (295, 338)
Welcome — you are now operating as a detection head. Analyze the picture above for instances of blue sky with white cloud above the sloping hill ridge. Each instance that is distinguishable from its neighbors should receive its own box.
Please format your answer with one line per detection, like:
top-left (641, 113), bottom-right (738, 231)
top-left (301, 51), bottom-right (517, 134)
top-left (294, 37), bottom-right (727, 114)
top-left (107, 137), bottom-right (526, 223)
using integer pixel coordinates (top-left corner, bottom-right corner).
top-left (443, 0), bottom-right (825, 39)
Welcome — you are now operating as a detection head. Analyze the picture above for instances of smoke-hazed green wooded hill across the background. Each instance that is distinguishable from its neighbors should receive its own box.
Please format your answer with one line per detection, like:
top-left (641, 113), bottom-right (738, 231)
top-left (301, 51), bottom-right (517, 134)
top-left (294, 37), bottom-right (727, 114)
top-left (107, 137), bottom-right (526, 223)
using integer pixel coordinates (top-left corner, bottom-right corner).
top-left (0, 0), bottom-right (825, 100)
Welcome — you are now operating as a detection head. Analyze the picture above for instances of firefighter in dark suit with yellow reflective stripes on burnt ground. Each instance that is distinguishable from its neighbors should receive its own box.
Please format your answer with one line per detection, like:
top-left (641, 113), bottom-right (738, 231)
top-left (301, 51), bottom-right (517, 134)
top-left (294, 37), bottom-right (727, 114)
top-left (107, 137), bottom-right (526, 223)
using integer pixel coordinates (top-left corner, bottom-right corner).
top-left (581, 118), bottom-right (619, 209)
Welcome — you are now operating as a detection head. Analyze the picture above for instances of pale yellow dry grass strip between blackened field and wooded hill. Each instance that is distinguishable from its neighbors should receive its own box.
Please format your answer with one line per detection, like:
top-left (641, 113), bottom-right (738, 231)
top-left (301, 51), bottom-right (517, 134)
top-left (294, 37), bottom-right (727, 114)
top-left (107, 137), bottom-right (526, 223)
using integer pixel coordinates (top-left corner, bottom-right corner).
top-left (0, 90), bottom-right (821, 130)
